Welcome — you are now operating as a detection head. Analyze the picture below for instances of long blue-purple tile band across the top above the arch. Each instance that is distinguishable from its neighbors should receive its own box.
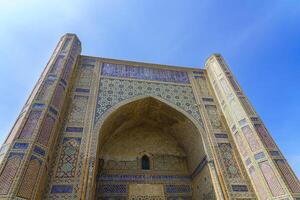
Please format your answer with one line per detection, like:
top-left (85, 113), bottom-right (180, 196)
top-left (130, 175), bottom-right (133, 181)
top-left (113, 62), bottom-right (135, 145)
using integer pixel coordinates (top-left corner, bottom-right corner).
top-left (102, 63), bottom-right (190, 84)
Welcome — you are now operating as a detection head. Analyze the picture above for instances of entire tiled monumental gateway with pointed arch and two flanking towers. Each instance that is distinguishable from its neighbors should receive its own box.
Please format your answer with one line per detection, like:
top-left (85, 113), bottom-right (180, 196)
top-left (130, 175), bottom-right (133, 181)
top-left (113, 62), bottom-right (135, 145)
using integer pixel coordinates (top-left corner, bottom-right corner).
top-left (0, 34), bottom-right (300, 200)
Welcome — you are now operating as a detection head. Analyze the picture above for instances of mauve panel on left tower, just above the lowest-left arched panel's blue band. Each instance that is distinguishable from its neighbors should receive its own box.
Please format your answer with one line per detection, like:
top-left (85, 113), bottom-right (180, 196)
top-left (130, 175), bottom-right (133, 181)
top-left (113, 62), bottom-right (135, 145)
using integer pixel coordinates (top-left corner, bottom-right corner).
top-left (19, 110), bottom-right (42, 139)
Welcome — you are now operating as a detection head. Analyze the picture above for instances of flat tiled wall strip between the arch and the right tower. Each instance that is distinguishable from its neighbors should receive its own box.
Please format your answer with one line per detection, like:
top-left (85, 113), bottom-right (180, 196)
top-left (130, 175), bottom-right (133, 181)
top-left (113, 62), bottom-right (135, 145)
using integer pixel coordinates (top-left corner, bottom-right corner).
top-left (191, 70), bottom-right (255, 199)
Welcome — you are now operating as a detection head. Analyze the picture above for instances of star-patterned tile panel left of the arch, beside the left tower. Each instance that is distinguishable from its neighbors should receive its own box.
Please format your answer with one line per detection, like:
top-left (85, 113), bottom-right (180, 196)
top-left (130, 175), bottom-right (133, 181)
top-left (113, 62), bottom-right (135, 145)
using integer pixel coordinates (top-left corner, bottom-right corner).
top-left (56, 138), bottom-right (81, 178)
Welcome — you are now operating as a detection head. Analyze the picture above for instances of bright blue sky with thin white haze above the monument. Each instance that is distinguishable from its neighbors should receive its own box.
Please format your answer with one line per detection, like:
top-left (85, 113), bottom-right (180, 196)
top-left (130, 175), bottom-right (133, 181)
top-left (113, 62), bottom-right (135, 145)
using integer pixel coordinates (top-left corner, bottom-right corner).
top-left (0, 0), bottom-right (300, 177)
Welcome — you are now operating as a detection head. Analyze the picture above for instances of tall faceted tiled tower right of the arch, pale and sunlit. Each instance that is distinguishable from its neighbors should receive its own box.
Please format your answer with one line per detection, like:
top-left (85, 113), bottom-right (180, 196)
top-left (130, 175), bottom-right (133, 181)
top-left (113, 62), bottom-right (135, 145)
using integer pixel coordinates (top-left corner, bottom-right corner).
top-left (205, 55), bottom-right (299, 199)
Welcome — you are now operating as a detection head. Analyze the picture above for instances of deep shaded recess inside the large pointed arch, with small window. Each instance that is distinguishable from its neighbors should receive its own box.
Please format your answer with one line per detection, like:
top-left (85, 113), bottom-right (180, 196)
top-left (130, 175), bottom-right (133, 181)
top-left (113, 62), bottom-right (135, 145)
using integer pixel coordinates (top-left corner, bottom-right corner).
top-left (95, 97), bottom-right (214, 199)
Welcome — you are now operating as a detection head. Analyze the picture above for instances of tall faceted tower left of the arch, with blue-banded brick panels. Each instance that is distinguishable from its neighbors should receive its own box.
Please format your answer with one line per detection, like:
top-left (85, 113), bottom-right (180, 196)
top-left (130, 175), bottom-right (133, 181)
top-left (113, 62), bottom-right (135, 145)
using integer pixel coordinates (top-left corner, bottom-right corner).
top-left (0, 34), bottom-right (81, 199)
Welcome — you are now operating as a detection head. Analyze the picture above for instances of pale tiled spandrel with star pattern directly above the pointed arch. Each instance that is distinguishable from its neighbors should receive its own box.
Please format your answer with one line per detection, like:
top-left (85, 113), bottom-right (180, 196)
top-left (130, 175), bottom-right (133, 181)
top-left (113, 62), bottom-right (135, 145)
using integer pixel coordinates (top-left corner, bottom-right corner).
top-left (95, 78), bottom-right (202, 125)
